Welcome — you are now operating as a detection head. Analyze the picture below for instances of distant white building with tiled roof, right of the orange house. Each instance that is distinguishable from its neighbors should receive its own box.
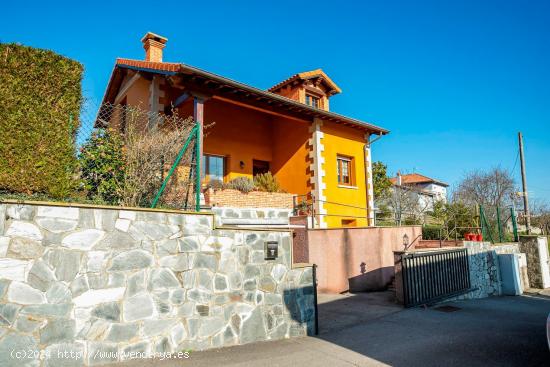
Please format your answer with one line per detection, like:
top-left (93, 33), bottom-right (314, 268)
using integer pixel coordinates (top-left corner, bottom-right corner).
top-left (390, 173), bottom-right (449, 211)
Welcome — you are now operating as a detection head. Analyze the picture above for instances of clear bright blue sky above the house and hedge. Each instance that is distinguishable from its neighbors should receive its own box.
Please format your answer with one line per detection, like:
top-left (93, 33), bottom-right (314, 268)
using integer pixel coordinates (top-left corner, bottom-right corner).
top-left (0, 0), bottom-right (550, 201)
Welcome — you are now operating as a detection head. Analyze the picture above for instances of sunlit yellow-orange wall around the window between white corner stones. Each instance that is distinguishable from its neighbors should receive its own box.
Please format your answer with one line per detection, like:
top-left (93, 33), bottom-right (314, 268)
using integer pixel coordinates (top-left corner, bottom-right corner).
top-left (321, 121), bottom-right (368, 228)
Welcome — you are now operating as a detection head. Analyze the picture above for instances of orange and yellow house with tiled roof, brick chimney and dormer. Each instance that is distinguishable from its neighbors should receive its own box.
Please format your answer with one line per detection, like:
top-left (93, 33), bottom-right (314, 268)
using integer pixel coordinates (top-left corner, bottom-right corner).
top-left (103, 33), bottom-right (388, 228)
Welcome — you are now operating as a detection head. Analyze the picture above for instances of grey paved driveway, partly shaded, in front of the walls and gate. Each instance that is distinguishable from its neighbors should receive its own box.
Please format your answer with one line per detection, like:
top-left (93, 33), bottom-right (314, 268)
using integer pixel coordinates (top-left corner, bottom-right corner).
top-left (116, 295), bottom-right (550, 367)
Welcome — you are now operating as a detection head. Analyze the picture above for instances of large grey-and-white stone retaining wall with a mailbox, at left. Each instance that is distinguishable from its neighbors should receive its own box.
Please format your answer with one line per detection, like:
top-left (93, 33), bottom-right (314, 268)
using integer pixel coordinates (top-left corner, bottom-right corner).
top-left (0, 204), bottom-right (314, 366)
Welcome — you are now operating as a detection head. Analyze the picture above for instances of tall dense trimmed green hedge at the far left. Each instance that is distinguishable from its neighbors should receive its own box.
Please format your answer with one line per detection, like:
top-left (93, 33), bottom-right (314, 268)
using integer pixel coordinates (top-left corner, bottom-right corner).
top-left (0, 44), bottom-right (83, 198)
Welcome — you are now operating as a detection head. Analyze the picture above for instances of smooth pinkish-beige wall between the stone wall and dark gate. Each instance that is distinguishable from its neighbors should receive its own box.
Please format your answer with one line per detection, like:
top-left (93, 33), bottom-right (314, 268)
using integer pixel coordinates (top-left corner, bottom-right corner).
top-left (307, 226), bottom-right (422, 293)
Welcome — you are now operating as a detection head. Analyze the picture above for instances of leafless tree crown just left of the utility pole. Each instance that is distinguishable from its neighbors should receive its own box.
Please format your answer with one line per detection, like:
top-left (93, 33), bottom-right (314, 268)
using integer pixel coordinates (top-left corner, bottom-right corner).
top-left (453, 167), bottom-right (517, 207)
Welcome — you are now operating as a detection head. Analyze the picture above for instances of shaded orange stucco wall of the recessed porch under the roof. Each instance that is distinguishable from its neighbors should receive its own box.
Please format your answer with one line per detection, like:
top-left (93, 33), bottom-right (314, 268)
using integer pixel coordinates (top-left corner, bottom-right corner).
top-left (198, 99), bottom-right (310, 195)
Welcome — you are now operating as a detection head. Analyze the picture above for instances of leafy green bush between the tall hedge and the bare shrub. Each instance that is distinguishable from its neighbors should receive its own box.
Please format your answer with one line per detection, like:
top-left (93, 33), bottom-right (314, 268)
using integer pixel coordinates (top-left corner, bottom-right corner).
top-left (79, 129), bottom-right (125, 205)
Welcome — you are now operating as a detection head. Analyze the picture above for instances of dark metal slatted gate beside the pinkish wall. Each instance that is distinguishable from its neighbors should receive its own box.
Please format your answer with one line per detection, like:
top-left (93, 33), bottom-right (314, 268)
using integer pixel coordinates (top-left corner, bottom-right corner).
top-left (401, 249), bottom-right (470, 307)
